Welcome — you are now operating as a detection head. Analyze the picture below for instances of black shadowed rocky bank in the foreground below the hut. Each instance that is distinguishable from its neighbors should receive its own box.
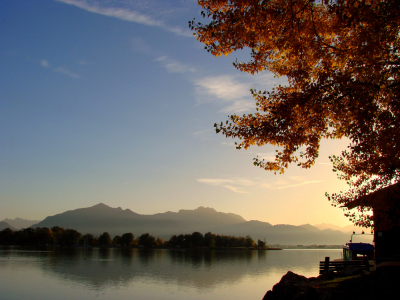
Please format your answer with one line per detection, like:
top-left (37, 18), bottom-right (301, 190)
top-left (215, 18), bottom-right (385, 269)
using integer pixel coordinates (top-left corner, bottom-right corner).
top-left (263, 267), bottom-right (400, 300)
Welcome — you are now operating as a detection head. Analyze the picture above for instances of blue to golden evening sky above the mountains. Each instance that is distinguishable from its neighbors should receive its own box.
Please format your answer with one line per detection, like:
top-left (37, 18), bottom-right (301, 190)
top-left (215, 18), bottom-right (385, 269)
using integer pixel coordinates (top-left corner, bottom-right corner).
top-left (0, 0), bottom-right (360, 226)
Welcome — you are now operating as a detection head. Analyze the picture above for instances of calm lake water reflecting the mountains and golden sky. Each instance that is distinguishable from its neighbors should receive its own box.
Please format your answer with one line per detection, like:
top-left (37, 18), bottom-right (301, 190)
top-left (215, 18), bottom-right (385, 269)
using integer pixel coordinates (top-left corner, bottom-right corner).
top-left (0, 248), bottom-right (341, 300)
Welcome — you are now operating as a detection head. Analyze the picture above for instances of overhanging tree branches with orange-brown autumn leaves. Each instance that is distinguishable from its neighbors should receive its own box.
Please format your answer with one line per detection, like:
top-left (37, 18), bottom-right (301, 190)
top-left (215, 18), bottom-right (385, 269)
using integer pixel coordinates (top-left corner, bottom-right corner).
top-left (189, 0), bottom-right (400, 226)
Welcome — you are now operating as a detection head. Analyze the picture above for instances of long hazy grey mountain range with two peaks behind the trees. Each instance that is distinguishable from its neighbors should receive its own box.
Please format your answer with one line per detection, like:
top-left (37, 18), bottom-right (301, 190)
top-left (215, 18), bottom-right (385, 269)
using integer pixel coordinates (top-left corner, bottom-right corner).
top-left (25, 203), bottom-right (370, 245)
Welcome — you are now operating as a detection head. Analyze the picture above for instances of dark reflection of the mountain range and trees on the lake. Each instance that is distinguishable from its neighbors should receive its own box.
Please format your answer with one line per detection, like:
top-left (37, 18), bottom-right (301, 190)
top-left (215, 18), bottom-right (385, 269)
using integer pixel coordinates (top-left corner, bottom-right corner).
top-left (27, 248), bottom-right (340, 289)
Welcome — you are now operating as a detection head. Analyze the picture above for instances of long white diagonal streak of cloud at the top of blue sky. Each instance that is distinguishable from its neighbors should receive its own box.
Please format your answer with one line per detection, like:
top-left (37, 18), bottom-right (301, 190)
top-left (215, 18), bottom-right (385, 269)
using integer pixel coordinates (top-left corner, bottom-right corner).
top-left (56, 0), bottom-right (193, 36)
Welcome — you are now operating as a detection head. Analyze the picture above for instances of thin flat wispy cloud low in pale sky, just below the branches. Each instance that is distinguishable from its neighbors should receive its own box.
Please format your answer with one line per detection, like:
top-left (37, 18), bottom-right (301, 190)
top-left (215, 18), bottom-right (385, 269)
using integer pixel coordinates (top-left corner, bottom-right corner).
top-left (197, 177), bottom-right (323, 194)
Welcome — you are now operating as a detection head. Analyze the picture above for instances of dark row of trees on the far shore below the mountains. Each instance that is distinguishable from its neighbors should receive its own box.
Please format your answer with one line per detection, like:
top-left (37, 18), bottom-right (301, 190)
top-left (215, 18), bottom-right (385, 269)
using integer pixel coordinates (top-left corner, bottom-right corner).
top-left (0, 226), bottom-right (278, 249)
